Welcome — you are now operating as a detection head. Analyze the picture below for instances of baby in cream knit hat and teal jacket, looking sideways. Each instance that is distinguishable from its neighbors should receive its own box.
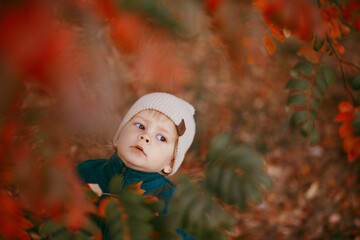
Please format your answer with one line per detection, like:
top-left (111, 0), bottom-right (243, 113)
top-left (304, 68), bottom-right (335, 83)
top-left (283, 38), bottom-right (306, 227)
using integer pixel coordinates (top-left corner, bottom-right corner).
top-left (77, 93), bottom-right (195, 239)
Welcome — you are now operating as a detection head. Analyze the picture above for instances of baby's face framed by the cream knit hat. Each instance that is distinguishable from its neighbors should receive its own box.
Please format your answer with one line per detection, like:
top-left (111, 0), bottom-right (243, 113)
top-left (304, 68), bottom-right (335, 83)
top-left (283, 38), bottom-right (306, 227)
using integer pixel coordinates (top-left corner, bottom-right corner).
top-left (116, 110), bottom-right (178, 173)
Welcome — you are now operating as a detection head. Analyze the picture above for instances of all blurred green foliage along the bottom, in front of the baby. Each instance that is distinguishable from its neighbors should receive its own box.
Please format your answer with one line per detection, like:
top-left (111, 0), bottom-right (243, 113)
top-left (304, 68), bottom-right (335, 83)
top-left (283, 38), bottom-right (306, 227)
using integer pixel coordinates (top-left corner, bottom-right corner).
top-left (33, 134), bottom-right (271, 240)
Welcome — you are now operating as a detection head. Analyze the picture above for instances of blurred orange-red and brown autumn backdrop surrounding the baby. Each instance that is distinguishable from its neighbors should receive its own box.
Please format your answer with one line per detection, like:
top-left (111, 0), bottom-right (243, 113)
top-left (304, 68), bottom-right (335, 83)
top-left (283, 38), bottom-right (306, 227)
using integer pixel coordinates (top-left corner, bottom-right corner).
top-left (0, 0), bottom-right (360, 239)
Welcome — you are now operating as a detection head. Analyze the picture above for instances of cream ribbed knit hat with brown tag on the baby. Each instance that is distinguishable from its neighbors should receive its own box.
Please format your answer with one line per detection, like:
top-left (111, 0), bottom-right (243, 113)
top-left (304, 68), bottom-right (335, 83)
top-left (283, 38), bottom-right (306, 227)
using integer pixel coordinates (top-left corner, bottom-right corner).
top-left (113, 92), bottom-right (195, 176)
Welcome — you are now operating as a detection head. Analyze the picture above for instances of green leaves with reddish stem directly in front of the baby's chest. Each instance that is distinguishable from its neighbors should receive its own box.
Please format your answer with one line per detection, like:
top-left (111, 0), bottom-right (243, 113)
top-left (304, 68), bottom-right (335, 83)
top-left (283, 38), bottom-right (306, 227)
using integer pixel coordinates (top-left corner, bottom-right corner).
top-left (104, 175), bottom-right (178, 240)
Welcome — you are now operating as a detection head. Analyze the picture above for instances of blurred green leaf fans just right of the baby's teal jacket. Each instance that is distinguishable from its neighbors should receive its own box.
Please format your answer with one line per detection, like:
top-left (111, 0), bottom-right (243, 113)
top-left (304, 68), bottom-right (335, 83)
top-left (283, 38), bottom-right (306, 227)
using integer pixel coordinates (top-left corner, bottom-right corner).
top-left (170, 133), bottom-right (272, 240)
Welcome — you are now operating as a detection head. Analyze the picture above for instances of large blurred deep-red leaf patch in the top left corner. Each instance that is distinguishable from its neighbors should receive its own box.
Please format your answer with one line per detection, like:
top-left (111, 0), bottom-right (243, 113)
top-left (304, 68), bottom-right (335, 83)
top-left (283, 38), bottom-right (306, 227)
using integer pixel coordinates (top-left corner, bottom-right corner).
top-left (0, 1), bottom-right (74, 86)
